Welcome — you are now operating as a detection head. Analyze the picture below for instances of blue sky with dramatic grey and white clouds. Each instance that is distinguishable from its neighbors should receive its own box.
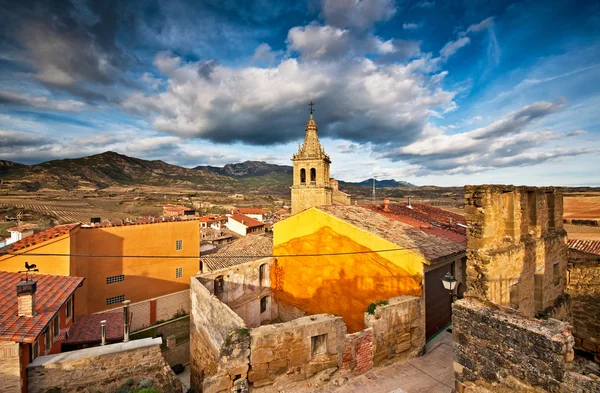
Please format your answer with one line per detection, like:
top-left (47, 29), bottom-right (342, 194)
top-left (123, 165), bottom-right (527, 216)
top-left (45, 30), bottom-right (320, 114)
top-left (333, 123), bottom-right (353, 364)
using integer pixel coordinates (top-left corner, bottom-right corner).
top-left (0, 0), bottom-right (600, 186)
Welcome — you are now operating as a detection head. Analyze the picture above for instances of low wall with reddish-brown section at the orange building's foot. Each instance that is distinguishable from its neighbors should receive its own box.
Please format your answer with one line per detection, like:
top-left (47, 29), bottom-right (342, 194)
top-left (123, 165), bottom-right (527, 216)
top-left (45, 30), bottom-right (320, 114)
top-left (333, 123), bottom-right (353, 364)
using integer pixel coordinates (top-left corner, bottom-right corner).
top-left (97, 289), bottom-right (190, 332)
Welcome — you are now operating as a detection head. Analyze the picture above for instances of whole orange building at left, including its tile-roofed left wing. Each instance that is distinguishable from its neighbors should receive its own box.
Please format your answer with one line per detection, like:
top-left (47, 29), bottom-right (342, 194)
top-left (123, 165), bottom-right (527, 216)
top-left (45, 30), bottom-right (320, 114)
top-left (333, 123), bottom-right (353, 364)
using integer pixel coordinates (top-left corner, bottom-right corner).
top-left (0, 220), bottom-right (200, 314)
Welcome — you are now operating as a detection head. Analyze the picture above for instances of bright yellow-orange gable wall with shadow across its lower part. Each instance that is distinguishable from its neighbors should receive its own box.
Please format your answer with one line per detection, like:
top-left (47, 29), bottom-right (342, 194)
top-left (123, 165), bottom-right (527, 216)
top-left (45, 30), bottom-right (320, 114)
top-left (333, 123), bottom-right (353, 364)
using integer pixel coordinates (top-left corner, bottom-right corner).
top-left (271, 208), bottom-right (423, 332)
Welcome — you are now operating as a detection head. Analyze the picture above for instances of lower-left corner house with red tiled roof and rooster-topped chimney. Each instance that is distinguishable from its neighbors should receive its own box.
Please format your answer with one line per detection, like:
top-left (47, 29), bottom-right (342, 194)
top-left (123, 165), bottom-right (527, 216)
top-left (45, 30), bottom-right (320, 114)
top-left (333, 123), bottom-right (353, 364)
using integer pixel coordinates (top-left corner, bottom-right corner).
top-left (0, 271), bottom-right (84, 393)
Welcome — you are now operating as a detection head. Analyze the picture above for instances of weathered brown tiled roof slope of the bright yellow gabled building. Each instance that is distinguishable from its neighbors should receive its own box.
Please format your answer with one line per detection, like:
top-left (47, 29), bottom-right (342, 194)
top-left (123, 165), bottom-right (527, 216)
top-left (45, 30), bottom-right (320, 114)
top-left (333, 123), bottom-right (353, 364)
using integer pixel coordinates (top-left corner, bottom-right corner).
top-left (316, 205), bottom-right (466, 262)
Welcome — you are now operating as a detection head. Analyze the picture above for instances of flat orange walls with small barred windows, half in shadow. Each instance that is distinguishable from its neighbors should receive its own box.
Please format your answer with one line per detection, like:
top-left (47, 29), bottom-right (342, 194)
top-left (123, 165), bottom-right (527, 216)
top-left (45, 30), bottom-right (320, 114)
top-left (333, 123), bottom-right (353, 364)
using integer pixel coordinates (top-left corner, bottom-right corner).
top-left (71, 220), bottom-right (200, 314)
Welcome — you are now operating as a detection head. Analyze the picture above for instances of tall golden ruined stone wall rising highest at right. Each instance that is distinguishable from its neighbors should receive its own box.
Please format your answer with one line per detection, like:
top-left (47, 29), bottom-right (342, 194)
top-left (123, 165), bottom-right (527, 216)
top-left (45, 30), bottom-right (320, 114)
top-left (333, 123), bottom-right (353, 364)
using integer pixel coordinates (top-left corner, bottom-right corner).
top-left (465, 185), bottom-right (567, 317)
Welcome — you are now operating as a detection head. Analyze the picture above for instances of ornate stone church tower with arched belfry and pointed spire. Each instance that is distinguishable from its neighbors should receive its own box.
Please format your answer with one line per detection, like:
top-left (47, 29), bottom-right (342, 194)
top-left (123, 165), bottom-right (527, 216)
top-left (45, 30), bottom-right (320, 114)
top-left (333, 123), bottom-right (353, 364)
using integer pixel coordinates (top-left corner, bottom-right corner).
top-left (292, 109), bottom-right (332, 214)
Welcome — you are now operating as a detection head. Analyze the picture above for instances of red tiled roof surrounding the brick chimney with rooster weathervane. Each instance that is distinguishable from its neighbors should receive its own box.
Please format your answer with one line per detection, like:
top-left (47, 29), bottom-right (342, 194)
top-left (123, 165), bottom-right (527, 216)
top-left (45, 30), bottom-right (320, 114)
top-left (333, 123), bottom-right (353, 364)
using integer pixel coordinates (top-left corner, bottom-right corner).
top-left (0, 272), bottom-right (85, 343)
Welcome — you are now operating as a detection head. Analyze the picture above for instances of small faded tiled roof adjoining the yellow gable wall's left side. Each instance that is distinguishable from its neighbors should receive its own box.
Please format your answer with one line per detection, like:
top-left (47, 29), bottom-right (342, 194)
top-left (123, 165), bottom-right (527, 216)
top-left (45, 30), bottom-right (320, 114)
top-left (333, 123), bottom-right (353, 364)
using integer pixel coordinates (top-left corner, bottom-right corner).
top-left (200, 235), bottom-right (273, 271)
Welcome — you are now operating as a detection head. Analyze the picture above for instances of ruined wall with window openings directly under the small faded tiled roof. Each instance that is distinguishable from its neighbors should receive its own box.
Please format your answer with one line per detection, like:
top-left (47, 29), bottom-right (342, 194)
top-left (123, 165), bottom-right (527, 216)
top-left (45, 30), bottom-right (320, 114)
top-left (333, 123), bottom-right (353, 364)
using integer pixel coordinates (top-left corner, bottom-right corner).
top-left (198, 258), bottom-right (278, 327)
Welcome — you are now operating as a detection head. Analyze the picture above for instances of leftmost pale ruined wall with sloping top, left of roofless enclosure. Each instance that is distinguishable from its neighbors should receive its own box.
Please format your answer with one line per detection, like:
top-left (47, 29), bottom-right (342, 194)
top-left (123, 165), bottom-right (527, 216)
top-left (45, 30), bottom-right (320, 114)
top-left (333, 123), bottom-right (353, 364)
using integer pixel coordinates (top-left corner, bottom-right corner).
top-left (190, 277), bottom-right (245, 392)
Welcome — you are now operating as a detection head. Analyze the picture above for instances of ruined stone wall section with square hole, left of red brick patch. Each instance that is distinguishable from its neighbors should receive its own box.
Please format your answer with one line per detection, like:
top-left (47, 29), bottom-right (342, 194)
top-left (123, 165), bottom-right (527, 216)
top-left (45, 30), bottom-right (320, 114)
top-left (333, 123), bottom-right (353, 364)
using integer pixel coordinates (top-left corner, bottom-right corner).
top-left (248, 314), bottom-right (346, 388)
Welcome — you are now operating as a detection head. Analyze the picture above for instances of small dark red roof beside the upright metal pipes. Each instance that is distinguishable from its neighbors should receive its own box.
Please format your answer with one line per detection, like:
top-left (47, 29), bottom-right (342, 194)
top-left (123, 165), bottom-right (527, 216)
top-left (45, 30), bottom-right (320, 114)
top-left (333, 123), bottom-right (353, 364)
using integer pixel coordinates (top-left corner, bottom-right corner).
top-left (64, 312), bottom-right (125, 344)
